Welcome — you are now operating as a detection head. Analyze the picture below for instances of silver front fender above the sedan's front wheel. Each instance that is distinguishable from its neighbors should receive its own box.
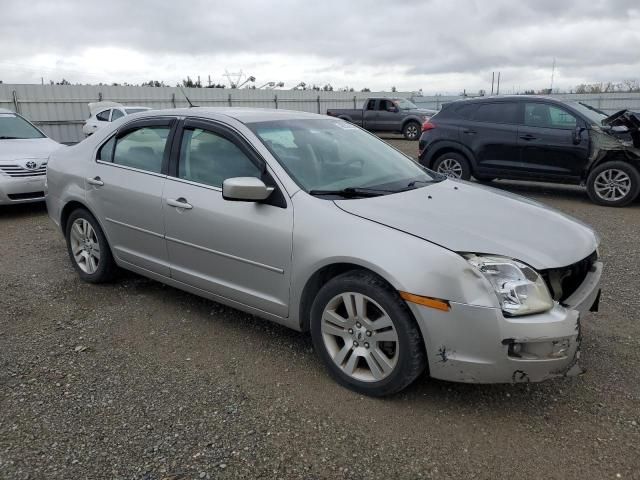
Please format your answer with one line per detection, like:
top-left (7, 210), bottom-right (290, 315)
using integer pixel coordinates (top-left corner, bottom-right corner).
top-left (289, 194), bottom-right (497, 324)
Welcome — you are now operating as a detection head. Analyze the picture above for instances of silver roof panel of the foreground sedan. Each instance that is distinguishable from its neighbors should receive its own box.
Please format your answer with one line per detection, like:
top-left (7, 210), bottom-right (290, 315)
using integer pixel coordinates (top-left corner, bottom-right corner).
top-left (136, 107), bottom-right (328, 123)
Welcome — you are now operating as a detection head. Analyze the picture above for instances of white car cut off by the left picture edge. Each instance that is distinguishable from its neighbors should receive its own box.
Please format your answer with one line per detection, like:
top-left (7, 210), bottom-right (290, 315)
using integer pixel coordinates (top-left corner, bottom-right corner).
top-left (0, 108), bottom-right (62, 205)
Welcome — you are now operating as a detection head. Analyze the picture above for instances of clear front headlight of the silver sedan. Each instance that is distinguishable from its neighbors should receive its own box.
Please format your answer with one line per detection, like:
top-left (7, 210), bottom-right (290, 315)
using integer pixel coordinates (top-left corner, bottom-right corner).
top-left (464, 253), bottom-right (553, 316)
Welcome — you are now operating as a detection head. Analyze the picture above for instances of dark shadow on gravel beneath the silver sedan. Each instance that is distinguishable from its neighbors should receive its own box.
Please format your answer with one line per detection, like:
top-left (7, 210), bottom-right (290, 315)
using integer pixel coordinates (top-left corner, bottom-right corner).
top-left (115, 272), bottom-right (568, 414)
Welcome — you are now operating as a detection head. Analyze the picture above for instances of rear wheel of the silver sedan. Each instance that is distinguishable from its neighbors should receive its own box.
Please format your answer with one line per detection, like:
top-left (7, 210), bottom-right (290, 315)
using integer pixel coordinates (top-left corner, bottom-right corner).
top-left (66, 209), bottom-right (116, 283)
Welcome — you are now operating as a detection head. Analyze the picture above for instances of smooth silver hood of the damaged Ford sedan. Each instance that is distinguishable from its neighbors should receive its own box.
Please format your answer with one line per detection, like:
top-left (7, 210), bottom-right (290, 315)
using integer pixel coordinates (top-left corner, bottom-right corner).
top-left (335, 180), bottom-right (597, 270)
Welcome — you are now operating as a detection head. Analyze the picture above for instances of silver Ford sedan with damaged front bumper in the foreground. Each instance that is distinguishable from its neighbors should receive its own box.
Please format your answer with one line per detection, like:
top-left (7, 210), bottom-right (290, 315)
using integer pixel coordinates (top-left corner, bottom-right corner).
top-left (47, 108), bottom-right (602, 395)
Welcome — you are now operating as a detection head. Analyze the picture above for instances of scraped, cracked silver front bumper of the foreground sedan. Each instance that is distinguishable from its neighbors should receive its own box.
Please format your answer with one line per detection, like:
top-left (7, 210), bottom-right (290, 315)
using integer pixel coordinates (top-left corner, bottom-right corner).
top-left (408, 262), bottom-right (602, 383)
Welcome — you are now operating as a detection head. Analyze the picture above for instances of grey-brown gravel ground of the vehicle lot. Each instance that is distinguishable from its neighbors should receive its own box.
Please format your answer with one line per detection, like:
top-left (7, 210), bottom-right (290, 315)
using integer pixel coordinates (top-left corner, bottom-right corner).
top-left (0, 138), bottom-right (640, 480)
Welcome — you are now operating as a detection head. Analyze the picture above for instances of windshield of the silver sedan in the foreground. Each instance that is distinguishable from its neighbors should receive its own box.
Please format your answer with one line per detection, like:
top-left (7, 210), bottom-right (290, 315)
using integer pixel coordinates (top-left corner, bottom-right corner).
top-left (247, 119), bottom-right (441, 193)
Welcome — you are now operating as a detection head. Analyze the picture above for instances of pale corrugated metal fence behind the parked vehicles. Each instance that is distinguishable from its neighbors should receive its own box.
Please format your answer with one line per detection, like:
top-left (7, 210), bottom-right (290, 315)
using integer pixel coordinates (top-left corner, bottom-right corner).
top-left (0, 84), bottom-right (640, 143)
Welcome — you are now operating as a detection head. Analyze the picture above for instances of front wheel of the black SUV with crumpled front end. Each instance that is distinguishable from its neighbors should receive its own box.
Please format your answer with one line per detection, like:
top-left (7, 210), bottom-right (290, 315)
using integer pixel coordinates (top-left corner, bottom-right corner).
top-left (587, 161), bottom-right (640, 207)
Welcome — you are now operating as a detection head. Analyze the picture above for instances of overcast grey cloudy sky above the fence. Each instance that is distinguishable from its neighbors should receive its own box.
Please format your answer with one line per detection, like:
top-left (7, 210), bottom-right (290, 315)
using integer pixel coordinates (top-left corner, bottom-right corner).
top-left (0, 0), bottom-right (640, 93)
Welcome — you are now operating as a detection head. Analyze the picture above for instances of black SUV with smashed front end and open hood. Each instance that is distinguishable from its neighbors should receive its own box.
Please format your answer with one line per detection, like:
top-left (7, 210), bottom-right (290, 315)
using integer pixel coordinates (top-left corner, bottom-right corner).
top-left (419, 95), bottom-right (640, 206)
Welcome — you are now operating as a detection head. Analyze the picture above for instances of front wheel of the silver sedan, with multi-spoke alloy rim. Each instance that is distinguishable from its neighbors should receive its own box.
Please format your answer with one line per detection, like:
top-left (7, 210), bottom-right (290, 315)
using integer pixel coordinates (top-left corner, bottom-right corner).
top-left (311, 272), bottom-right (426, 396)
